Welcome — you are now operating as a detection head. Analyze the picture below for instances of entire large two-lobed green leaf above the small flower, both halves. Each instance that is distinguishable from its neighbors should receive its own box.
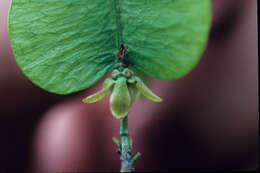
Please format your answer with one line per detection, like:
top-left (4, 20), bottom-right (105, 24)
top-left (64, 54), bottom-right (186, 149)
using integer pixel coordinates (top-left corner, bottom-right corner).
top-left (8, 0), bottom-right (210, 94)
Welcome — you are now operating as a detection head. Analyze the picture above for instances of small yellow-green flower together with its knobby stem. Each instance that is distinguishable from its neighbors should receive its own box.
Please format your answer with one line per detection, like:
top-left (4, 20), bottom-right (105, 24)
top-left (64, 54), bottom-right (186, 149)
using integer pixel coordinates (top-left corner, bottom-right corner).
top-left (82, 44), bottom-right (162, 172)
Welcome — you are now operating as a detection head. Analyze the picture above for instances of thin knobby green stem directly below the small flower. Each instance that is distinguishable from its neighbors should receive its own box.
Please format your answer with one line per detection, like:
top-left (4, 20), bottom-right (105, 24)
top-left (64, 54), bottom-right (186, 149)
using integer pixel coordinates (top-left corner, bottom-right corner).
top-left (113, 116), bottom-right (141, 172)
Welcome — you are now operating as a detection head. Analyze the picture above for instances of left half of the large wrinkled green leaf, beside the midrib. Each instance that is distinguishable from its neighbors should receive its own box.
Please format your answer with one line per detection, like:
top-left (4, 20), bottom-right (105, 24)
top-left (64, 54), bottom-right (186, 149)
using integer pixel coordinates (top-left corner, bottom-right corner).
top-left (9, 0), bottom-right (117, 94)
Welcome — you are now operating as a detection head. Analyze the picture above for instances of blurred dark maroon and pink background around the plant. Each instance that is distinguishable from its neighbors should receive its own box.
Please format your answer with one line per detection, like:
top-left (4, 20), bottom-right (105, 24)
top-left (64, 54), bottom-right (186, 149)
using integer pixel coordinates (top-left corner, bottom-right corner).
top-left (0, 0), bottom-right (259, 173)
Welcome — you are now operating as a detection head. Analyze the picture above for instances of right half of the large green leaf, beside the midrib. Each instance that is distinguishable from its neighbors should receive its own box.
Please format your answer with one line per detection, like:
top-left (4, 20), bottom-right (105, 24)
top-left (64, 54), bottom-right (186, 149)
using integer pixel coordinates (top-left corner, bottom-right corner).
top-left (120, 0), bottom-right (211, 80)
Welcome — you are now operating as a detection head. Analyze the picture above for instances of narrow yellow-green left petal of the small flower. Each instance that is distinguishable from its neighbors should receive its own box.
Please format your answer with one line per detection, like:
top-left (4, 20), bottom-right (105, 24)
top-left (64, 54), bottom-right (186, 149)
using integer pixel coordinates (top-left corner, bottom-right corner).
top-left (82, 78), bottom-right (116, 103)
